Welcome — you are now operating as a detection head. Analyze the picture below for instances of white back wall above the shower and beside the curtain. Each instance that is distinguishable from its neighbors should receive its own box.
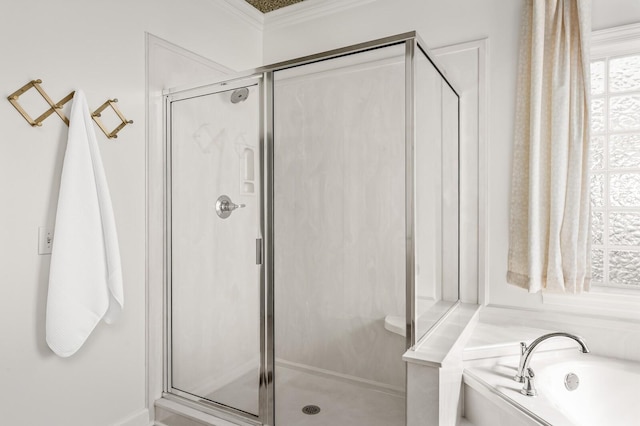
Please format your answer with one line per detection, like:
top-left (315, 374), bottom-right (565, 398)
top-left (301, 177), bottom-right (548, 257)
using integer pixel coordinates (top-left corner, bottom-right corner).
top-left (264, 0), bottom-right (640, 308)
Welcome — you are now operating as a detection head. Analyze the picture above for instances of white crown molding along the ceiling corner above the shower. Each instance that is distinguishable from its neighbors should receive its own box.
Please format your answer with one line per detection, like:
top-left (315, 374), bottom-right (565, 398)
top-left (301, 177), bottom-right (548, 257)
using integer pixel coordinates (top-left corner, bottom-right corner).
top-left (214, 0), bottom-right (377, 31)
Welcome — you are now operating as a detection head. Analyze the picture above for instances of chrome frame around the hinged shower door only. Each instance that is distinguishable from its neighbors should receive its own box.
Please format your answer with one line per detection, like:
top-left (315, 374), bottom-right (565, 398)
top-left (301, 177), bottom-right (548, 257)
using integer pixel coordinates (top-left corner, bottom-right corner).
top-left (162, 72), bottom-right (274, 425)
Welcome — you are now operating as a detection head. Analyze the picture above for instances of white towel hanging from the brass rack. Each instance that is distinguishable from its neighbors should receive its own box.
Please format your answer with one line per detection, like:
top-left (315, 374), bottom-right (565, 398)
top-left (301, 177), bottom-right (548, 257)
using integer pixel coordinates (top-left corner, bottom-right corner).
top-left (46, 90), bottom-right (124, 357)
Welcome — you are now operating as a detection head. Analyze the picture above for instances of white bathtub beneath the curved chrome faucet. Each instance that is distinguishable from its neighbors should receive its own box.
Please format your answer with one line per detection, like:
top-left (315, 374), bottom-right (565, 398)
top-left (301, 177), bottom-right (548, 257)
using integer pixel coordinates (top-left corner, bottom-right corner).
top-left (464, 349), bottom-right (640, 426)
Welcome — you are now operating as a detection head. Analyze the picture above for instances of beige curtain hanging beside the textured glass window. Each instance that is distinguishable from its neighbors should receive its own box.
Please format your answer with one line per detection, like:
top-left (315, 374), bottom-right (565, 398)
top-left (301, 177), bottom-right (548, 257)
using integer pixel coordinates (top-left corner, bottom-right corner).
top-left (507, 0), bottom-right (591, 293)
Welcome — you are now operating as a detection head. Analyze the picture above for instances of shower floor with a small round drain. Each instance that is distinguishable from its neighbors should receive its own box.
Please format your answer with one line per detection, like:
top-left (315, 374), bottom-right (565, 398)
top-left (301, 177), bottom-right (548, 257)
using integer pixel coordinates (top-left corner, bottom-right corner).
top-left (207, 366), bottom-right (405, 426)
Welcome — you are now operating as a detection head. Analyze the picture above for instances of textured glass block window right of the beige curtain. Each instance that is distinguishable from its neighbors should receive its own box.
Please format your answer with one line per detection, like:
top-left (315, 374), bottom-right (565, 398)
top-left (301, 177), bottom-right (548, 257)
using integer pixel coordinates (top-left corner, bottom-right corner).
top-left (590, 51), bottom-right (640, 290)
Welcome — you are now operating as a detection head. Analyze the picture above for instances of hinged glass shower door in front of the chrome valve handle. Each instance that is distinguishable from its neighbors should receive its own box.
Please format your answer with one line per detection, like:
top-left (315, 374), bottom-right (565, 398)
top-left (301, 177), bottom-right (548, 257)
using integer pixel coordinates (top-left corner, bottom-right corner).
top-left (166, 79), bottom-right (266, 421)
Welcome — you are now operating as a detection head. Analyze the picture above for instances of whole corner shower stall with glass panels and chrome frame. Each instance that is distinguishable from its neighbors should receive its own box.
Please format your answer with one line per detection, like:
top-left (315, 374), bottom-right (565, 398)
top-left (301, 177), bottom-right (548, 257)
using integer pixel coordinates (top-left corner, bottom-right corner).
top-left (164, 33), bottom-right (459, 426)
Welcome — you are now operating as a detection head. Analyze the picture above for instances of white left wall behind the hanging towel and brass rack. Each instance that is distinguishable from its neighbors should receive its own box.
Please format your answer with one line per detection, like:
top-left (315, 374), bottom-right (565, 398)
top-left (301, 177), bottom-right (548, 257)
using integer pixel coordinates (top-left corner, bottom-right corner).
top-left (0, 0), bottom-right (262, 426)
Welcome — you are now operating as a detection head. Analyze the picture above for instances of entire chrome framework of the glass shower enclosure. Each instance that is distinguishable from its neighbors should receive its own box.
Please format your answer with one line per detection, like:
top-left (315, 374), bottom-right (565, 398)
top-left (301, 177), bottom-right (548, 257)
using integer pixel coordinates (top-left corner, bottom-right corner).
top-left (163, 31), bottom-right (460, 426)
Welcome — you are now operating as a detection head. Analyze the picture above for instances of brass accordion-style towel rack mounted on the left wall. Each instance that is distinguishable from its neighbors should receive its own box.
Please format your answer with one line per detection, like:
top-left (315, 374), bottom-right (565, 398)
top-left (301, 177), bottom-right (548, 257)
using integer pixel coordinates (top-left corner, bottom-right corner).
top-left (7, 79), bottom-right (133, 139)
